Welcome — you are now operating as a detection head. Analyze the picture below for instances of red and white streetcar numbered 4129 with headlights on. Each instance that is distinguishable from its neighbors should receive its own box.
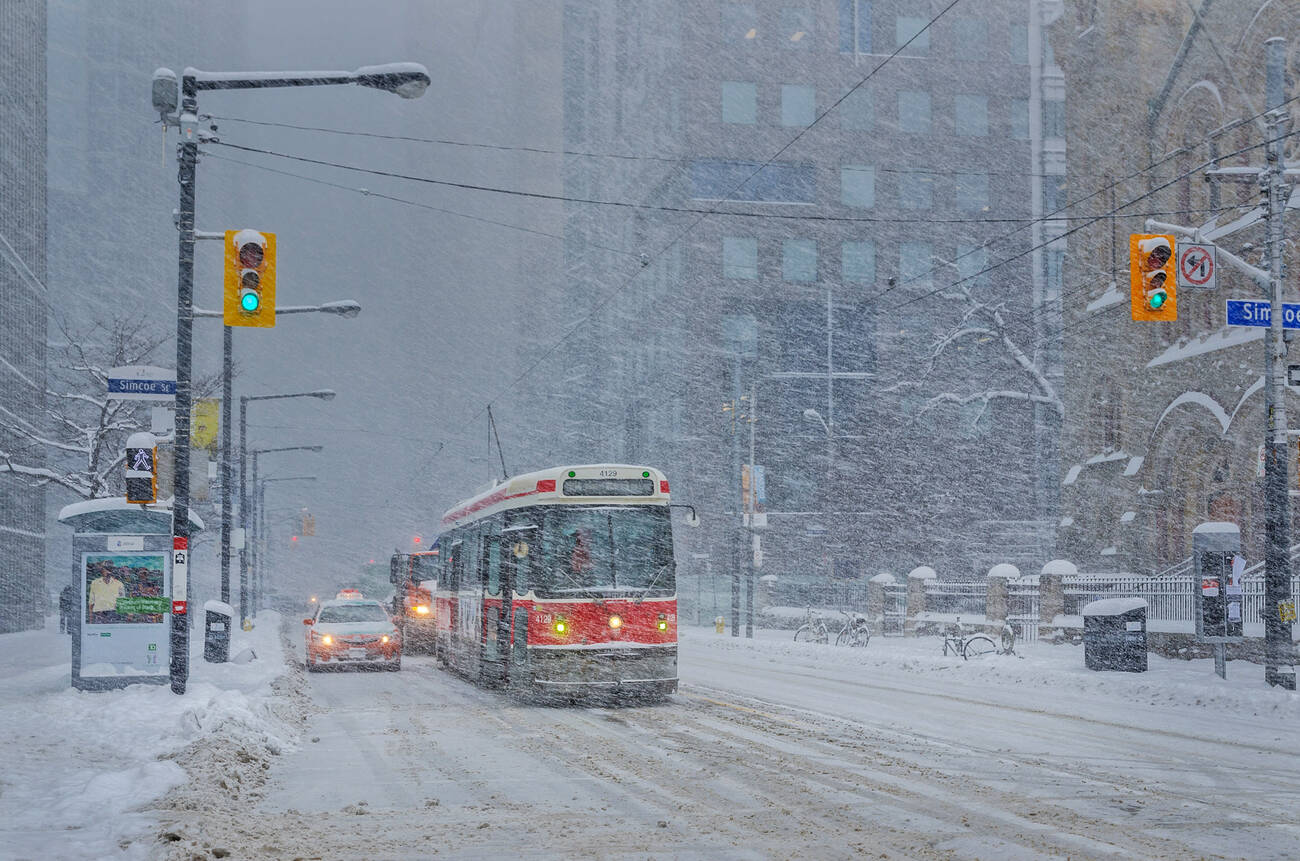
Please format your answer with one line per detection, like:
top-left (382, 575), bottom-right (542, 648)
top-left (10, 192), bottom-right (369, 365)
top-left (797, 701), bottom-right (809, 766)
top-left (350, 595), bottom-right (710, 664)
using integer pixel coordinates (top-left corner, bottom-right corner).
top-left (430, 464), bottom-right (698, 697)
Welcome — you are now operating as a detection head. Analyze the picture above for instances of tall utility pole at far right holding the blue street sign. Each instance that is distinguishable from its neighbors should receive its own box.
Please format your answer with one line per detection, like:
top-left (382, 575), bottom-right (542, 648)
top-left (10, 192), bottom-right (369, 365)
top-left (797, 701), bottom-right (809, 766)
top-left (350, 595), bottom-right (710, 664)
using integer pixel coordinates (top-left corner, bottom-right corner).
top-left (1193, 38), bottom-right (1296, 691)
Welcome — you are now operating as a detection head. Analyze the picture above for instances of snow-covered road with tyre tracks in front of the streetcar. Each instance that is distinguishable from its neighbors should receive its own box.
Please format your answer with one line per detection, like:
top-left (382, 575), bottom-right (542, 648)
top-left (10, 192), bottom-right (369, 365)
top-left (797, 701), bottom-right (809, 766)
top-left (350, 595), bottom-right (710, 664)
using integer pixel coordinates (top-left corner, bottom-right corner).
top-left (154, 629), bottom-right (1300, 858)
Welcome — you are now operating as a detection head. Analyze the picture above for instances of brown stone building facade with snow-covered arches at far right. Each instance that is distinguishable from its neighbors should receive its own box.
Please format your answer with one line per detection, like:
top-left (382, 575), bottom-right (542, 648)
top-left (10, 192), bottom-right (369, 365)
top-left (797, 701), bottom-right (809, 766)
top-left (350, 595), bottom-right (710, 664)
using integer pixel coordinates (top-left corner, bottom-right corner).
top-left (1049, 0), bottom-right (1300, 574)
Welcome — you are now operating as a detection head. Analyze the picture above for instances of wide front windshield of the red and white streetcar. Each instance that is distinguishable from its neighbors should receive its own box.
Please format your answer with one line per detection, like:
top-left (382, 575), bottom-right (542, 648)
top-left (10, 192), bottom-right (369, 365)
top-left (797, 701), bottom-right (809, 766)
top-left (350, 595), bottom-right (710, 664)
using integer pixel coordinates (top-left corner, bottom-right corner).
top-left (534, 506), bottom-right (676, 596)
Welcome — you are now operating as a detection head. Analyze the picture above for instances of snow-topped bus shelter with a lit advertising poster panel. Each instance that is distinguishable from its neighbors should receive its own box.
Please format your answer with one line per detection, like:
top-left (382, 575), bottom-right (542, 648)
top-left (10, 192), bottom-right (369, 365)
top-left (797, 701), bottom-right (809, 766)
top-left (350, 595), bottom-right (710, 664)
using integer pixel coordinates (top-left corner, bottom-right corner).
top-left (59, 497), bottom-right (203, 691)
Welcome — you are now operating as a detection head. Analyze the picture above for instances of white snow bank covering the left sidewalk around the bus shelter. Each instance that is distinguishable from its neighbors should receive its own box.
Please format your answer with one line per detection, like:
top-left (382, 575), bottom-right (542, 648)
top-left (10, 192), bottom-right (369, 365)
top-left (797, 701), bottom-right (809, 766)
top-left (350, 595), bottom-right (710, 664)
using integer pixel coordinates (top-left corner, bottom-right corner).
top-left (0, 614), bottom-right (294, 858)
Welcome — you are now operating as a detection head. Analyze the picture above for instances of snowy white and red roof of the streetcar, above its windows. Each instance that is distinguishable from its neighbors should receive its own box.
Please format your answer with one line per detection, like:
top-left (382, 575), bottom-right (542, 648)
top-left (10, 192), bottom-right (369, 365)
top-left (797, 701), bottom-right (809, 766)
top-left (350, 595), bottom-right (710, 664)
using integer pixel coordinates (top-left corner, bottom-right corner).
top-left (442, 463), bottom-right (668, 529)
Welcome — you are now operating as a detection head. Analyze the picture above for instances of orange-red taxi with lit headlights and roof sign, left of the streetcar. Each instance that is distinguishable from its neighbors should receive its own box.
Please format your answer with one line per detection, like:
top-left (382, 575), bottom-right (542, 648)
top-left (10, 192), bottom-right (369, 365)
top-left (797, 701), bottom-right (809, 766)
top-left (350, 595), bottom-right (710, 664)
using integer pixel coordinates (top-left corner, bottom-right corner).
top-left (303, 598), bottom-right (402, 672)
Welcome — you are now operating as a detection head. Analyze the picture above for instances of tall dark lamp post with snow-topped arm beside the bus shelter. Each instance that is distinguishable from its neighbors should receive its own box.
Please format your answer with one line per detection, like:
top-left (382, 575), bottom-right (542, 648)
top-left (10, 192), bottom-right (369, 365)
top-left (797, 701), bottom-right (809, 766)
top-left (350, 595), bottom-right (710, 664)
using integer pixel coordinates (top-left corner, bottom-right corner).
top-left (152, 62), bottom-right (430, 693)
